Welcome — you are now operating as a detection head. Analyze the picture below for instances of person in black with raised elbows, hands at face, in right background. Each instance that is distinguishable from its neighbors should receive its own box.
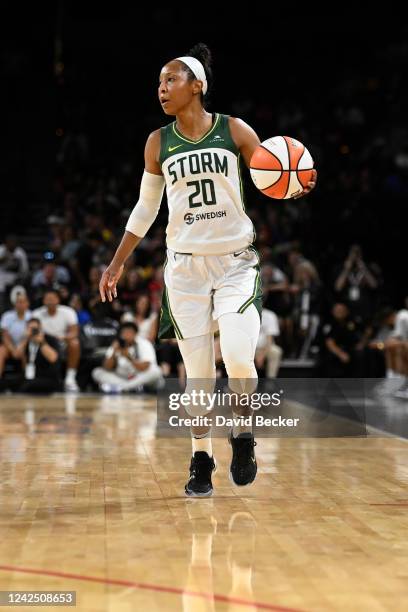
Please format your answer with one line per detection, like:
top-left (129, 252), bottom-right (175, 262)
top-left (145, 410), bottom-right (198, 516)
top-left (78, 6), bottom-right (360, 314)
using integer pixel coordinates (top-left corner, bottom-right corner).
top-left (334, 244), bottom-right (379, 321)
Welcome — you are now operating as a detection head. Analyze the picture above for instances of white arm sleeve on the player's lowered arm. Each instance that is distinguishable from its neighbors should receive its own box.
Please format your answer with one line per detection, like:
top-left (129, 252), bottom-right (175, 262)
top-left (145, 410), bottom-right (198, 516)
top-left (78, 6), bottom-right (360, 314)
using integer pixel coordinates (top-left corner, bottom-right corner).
top-left (126, 170), bottom-right (165, 238)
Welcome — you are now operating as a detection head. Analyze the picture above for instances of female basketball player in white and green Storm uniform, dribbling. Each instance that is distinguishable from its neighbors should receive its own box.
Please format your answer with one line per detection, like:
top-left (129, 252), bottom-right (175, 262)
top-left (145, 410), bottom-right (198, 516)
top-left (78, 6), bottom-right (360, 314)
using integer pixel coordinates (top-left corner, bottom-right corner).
top-left (100, 44), bottom-right (316, 497)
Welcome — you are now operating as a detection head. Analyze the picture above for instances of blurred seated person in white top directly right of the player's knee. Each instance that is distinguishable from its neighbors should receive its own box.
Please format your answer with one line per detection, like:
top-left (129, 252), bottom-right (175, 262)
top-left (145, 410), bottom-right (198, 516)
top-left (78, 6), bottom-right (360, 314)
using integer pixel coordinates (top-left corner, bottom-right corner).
top-left (255, 308), bottom-right (283, 378)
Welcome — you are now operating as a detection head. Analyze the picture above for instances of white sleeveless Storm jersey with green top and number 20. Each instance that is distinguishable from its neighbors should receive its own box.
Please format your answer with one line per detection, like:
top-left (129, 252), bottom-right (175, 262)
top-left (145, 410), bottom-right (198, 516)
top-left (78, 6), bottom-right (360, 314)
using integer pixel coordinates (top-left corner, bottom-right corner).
top-left (160, 114), bottom-right (255, 255)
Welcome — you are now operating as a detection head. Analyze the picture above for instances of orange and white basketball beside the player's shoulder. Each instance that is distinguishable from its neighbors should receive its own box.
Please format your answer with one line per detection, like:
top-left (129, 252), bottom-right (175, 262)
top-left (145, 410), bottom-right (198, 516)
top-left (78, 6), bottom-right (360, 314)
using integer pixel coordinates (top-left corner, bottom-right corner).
top-left (250, 136), bottom-right (313, 200)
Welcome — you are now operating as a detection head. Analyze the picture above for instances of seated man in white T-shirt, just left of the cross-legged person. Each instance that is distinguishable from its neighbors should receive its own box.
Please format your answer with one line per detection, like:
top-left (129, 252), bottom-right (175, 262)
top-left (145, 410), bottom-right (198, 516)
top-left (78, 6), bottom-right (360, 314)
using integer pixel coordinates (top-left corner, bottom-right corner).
top-left (33, 290), bottom-right (81, 391)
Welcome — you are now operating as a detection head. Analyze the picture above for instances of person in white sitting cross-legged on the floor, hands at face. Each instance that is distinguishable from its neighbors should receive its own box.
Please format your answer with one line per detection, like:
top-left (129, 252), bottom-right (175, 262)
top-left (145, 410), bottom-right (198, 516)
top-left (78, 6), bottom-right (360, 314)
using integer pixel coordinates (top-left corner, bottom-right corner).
top-left (92, 322), bottom-right (163, 393)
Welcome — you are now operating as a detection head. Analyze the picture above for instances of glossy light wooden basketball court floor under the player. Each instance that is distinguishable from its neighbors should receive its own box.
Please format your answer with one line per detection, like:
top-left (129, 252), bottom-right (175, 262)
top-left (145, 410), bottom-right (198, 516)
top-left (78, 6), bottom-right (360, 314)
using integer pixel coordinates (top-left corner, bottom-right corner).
top-left (0, 395), bottom-right (408, 612)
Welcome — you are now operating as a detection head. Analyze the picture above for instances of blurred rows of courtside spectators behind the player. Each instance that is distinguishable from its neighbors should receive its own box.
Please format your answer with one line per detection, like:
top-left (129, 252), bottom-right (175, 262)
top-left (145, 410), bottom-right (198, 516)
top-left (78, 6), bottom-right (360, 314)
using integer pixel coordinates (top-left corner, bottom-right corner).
top-left (0, 227), bottom-right (408, 393)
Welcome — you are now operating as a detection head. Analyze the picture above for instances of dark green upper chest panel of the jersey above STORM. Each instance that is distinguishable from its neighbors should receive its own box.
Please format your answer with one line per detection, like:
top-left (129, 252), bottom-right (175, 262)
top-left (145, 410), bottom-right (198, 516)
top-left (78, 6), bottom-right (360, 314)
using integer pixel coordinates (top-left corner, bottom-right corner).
top-left (159, 113), bottom-right (241, 167)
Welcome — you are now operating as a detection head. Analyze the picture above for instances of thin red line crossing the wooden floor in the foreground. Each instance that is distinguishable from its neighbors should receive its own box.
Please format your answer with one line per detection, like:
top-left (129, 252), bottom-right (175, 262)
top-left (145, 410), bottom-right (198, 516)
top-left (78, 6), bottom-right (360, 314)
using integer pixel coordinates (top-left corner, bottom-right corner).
top-left (0, 565), bottom-right (302, 612)
